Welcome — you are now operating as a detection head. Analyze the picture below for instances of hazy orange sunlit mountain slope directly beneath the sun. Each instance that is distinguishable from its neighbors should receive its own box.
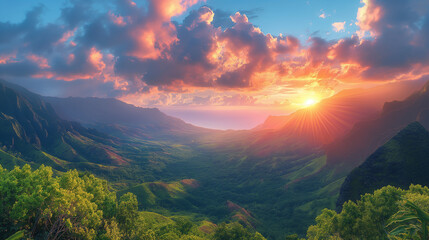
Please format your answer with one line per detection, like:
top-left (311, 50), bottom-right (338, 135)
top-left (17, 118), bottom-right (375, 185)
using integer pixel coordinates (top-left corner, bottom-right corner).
top-left (253, 80), bottom-right (425, 145)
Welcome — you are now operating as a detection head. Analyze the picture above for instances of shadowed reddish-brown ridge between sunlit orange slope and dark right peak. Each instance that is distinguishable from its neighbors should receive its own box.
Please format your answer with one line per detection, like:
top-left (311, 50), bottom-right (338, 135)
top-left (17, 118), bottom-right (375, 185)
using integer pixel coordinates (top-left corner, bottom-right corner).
top-left (326, 82), bottom-right (429, 172)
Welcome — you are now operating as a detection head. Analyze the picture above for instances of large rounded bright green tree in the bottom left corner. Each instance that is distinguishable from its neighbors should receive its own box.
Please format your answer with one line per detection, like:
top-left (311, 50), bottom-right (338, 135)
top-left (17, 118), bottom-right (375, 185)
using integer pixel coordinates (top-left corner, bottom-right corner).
top-left (0, 165), bottom-right (110, 239)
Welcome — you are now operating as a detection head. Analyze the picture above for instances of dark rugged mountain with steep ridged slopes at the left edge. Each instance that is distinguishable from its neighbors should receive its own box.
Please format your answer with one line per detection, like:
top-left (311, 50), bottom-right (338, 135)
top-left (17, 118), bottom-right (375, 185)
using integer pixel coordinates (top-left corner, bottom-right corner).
top-left (0, 82), bottom-right (132, 169)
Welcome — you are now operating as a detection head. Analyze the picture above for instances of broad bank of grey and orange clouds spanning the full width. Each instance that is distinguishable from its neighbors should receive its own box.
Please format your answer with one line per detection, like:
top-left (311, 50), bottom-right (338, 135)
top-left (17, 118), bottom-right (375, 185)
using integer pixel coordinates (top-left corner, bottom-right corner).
top-left (0, 0), bottom-right (429, 105)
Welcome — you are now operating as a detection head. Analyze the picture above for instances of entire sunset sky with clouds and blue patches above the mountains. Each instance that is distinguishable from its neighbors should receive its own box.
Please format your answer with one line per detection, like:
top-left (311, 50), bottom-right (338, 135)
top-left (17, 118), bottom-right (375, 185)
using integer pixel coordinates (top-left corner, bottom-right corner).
top-left (0, 0), bottom-right (429, 129)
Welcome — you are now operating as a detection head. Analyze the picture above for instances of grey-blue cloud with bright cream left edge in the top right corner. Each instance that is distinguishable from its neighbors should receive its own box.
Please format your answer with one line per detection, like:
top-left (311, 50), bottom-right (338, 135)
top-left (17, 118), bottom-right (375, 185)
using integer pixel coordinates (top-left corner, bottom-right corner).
top-left (333, 0), bottom-right (429, 81)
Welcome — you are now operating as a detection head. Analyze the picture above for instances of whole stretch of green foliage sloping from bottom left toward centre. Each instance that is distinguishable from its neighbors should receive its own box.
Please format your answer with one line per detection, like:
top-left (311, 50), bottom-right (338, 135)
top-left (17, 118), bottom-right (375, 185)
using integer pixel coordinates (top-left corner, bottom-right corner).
top-left (0, 165), bottom-right (264, 240)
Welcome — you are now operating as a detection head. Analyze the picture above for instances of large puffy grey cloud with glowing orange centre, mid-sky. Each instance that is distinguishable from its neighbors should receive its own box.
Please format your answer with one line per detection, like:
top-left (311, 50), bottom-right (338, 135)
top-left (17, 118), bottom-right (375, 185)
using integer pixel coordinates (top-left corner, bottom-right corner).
top-left (116, 7), bottom-right (299, 90)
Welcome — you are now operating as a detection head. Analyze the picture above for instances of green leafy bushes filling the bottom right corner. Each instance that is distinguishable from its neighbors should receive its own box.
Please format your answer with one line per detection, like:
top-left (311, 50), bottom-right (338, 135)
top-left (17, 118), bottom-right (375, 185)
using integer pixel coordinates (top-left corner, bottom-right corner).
top-left (307, 185), bottom-right (429, 239)
